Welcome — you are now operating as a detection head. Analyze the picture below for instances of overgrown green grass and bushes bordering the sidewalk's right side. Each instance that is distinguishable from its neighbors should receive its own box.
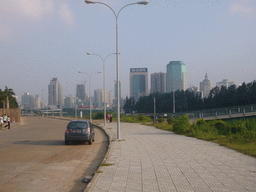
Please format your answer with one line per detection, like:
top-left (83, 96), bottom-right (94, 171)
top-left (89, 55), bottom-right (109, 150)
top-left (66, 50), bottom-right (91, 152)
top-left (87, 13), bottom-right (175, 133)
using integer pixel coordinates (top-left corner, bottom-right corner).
top-left (151, 116), bottom-right (256, 157)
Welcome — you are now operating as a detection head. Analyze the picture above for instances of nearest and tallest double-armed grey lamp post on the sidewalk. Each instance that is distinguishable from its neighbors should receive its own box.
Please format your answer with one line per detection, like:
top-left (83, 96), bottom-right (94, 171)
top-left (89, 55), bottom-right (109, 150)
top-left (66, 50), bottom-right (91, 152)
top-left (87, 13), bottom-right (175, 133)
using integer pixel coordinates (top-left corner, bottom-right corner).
top-left (85, 0), bottom-right (148, 140)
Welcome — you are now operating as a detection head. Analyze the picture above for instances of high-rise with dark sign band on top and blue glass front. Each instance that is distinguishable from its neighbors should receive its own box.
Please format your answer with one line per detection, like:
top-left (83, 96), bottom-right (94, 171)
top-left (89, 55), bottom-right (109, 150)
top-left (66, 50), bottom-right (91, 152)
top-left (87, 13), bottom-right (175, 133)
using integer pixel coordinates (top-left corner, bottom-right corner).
top-left (130, 68), bottom-right (148, 101)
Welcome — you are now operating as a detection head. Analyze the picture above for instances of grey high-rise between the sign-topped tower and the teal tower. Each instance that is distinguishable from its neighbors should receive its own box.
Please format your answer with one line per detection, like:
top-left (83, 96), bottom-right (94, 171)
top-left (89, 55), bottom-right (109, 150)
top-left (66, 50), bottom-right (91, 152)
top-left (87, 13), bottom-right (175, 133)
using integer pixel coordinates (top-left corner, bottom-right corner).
top-left (150, 72), bottom-right (166, 93)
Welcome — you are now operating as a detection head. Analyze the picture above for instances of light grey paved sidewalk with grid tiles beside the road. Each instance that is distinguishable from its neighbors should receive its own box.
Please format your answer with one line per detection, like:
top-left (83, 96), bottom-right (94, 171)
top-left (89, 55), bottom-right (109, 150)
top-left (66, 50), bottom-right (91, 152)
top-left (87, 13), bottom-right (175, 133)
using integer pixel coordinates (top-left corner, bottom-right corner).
top-left (86, 123), bottom-right (256, 192)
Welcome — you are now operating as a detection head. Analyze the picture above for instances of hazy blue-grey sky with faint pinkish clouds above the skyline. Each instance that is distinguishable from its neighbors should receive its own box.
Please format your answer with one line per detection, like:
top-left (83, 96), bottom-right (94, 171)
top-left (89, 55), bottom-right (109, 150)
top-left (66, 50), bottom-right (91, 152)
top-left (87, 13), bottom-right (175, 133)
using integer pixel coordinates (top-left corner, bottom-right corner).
top-left (0, 0), bottom-right (256, 102)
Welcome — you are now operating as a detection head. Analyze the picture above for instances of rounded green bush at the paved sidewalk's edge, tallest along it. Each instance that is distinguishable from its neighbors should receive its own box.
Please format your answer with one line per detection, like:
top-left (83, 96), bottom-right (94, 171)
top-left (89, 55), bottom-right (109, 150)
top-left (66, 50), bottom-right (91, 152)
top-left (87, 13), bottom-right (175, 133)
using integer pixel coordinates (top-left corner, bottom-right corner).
top-left (173, 115), bottom-right (191, 134)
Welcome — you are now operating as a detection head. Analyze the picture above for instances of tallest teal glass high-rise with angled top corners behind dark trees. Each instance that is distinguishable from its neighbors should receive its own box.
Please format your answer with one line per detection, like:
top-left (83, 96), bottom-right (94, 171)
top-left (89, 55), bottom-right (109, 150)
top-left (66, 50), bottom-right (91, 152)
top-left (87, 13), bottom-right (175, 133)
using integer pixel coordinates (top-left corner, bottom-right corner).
top-left (166, 61), bottom-right (187, 92)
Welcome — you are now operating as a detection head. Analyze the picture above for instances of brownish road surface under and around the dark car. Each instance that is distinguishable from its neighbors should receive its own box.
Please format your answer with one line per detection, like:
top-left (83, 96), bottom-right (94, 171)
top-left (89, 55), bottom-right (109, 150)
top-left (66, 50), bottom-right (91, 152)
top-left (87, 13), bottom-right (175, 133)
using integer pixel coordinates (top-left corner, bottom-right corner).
top-left (0, 116), bottom-right (107, 192)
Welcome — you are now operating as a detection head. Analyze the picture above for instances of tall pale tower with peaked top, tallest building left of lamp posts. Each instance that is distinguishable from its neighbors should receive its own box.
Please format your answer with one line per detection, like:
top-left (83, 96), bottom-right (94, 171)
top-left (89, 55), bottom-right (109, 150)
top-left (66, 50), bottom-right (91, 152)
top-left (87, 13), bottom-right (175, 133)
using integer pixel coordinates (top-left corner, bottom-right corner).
top-left (48, 78), bottom-right (64, 108)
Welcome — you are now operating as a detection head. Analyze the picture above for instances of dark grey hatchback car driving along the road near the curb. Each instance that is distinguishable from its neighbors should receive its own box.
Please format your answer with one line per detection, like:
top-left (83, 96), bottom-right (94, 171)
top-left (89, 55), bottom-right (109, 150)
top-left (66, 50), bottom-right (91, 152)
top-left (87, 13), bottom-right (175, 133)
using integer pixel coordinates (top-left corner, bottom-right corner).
top-left (65, 120), bottom-right (95, 145)
